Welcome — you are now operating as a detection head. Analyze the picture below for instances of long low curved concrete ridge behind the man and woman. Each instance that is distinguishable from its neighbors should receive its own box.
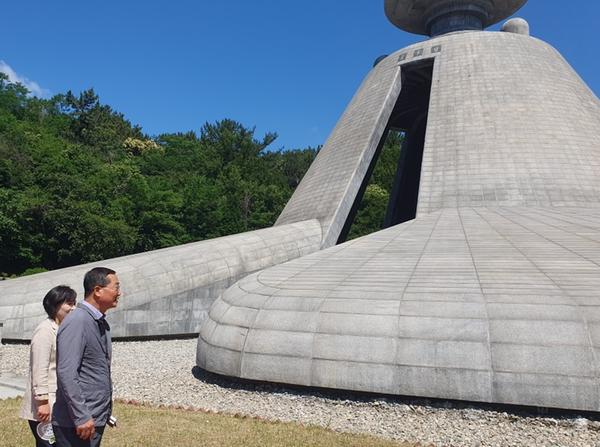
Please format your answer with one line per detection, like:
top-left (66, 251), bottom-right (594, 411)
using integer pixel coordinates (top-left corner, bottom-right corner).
top-left (0, 220), bottom-right (322, 340)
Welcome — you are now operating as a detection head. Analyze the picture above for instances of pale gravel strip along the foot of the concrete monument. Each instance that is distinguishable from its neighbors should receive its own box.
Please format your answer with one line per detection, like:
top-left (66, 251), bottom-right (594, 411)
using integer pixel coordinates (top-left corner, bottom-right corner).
top-left (0, 339), bottom-right (600, 447)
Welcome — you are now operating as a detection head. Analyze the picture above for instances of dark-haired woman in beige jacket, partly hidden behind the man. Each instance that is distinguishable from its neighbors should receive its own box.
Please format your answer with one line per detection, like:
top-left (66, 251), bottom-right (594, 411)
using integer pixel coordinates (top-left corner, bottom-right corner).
top-left (21, 286), bottom-right (77, 447)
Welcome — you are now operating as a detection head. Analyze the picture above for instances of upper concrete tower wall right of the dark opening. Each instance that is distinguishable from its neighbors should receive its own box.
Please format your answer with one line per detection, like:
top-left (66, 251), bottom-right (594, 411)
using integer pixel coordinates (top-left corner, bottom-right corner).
top-left (414, 32), bottom-right (600, 213)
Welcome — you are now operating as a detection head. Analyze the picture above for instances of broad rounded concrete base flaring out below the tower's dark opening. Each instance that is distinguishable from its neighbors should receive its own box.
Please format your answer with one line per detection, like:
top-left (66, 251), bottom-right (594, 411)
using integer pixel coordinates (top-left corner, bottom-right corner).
top-left (197, 207), bottom-right (600, 411)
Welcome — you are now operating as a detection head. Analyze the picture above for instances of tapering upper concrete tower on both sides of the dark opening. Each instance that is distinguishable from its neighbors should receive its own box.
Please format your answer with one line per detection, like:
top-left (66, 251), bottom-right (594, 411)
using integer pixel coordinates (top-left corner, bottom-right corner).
top-left (277, 32), bottom-right (600, 247)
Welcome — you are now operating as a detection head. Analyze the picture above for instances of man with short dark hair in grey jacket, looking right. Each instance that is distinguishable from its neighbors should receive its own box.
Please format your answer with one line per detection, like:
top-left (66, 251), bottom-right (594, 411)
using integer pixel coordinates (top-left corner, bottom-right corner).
top-left (52, 267), bottom-right (121, 447)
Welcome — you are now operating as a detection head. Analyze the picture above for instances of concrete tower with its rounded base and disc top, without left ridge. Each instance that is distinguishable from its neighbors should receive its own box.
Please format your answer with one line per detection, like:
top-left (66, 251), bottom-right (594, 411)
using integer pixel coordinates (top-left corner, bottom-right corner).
top-left (197, 0), bottom-right (600, 411)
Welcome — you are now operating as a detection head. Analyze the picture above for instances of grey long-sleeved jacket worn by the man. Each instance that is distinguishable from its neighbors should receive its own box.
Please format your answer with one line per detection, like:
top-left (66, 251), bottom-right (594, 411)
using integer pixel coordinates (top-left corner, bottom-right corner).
top-left (52, 303), bottom-right (112, 427)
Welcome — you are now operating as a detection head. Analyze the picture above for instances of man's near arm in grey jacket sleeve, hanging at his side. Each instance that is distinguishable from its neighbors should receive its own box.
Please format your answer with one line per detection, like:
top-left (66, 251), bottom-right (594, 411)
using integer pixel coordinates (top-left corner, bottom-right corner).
top-left (56, 318), bottom-right (93, 426)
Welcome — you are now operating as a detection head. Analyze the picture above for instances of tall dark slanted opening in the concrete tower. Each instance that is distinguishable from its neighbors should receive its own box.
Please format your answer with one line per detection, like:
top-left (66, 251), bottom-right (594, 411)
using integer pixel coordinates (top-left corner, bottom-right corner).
top-left (338, 59), bottom-right (434, 243)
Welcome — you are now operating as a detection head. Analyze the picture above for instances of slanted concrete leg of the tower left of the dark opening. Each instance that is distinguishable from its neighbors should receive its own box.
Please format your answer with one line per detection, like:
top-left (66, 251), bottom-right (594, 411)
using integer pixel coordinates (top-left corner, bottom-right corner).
top-left (276, 51), bottom-right (401, 247)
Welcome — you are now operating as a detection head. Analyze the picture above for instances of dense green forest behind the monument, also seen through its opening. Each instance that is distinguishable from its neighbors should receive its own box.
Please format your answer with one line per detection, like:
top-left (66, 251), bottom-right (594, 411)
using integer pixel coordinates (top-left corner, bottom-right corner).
top-left (0, 73), bottom-right (400, 277)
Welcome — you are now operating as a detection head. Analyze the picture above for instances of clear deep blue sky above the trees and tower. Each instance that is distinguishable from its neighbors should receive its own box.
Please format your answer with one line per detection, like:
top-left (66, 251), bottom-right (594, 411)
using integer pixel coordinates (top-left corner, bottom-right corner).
top-left (0, 0), bottom-right (600, 149)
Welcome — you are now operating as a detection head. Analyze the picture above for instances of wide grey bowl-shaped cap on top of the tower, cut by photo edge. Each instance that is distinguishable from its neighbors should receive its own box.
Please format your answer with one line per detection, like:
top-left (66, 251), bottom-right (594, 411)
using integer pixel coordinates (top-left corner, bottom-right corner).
top-left (385, 0), bottom-right (527, 36)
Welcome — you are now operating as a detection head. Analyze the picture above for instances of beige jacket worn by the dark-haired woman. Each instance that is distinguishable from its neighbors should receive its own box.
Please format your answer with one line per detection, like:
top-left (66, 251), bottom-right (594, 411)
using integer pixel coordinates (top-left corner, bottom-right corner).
top-left (21, 318), bottom-right (58, 421)
